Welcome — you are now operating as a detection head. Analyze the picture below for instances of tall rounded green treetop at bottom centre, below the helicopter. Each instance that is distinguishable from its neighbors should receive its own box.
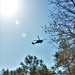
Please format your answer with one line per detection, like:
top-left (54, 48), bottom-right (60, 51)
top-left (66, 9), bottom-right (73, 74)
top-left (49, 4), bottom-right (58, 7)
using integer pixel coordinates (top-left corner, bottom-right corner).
top-left (21, 55), bottom-right (52, 75)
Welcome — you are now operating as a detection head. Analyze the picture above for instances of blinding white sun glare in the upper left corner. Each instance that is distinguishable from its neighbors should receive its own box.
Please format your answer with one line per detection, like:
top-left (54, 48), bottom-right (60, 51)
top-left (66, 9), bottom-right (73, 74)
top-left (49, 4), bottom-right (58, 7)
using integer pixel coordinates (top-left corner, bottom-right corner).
top-left (0, 0), bottom-right (18, 17)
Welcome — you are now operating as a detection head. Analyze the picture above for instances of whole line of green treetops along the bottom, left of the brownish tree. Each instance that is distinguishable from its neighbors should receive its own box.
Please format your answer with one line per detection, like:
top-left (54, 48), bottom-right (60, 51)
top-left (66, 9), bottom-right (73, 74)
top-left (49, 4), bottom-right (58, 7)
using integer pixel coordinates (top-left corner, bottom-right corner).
top-left (2, 55), bottom-right (52, 75)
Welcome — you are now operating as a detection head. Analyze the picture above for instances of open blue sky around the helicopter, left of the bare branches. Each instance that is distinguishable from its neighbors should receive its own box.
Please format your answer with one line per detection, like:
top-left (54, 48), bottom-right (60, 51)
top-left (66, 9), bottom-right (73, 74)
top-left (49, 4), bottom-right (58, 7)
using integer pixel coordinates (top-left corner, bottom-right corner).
top-left (0, 0), bottom-right (56, 70)
